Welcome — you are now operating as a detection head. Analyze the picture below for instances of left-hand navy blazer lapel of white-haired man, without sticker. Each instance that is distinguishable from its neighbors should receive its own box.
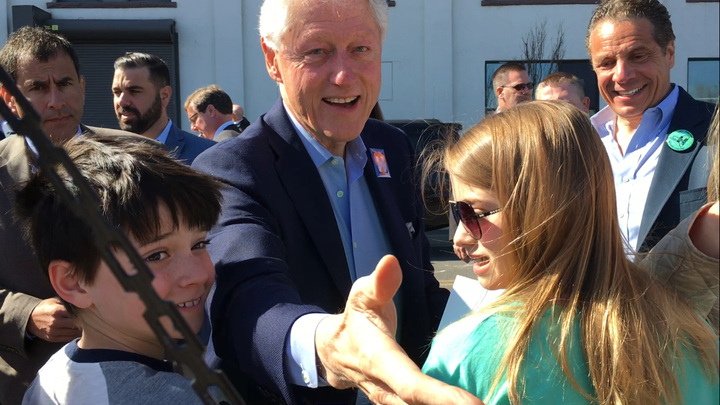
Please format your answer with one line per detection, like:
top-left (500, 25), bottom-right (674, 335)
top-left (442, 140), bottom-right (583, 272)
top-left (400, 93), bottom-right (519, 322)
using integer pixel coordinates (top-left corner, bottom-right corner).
top-left (265, 101), bottom-right (352, 296)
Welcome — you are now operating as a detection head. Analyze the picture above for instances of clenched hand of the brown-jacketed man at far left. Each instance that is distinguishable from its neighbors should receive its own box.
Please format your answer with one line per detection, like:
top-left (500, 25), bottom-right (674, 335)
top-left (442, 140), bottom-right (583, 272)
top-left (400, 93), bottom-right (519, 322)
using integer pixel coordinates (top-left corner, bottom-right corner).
top-left (27, 298), bottom-right (80, 342)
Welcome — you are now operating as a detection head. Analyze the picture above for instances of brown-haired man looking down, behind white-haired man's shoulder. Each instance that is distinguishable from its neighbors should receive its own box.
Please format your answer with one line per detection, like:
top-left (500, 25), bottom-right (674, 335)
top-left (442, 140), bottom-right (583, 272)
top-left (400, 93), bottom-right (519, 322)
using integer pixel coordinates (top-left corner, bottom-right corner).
top-left (185, 84), bottom-right (243, 142)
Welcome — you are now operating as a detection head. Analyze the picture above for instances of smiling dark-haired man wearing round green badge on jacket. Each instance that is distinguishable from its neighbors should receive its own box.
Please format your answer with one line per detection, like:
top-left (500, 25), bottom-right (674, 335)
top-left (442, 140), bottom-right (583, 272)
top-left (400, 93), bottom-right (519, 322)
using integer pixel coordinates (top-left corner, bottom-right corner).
top-left (586, 0), bottom-right (713, 252)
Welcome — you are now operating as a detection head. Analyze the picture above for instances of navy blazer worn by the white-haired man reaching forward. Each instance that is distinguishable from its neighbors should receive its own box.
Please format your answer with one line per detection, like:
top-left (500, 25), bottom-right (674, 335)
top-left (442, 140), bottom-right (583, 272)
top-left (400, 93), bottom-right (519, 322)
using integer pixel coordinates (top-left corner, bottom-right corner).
top-left (193, 100), bottom-right (448, 404)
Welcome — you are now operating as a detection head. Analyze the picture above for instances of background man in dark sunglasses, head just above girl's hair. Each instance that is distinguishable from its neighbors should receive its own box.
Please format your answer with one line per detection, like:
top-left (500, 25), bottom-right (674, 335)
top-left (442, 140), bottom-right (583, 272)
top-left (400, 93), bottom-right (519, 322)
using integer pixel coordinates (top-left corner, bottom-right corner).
top-left (493, 62), bottom-right (533, 112)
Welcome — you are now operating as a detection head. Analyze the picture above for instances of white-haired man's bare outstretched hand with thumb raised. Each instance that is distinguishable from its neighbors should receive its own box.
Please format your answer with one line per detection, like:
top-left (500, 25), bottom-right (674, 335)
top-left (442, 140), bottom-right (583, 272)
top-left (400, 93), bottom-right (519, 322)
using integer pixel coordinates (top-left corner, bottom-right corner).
top-left (315, 256), bottom-right (482, 405)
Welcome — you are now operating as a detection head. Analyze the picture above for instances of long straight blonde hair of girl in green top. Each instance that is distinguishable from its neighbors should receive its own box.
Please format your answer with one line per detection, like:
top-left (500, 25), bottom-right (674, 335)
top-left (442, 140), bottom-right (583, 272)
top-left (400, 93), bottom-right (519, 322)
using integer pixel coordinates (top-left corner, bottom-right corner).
top-left (428, 101), bottom-right (718, 405)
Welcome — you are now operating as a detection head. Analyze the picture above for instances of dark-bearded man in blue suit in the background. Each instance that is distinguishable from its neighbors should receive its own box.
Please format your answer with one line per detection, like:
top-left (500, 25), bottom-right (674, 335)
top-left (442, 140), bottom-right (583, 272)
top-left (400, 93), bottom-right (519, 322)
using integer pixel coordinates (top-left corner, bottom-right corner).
top-left (112, 52), bottom-right (215, 164)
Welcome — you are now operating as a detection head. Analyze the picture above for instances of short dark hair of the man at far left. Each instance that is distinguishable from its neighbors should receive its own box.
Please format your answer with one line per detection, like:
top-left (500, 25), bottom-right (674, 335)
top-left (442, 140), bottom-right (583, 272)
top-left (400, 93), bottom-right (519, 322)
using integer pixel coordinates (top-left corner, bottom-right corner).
top-left (0, 27), bottom-right (80, 81)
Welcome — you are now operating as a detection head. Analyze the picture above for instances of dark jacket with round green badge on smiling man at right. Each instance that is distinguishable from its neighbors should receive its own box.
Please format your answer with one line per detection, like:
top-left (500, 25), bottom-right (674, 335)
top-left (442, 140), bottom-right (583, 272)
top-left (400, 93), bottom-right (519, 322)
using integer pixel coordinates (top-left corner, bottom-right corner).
top-left (637, 87), bottom-right (714, 252)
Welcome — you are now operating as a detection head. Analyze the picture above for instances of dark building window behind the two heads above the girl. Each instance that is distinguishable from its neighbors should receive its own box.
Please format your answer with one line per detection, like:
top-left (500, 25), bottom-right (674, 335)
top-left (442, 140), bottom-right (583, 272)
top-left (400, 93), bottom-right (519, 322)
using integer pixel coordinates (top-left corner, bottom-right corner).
top-left (485, 59), bottom-right (600, 115)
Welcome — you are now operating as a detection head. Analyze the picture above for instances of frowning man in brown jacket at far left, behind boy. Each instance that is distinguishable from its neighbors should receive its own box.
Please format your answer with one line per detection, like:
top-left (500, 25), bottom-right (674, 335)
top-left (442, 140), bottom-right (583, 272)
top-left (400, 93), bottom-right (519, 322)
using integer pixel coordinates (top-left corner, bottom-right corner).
top-left (0, 27), bottom-right (139, 405)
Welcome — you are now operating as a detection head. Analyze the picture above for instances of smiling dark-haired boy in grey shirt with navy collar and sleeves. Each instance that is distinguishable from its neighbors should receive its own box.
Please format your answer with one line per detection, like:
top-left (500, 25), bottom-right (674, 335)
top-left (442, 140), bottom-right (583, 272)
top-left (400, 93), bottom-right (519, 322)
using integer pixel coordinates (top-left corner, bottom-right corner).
top-left (16, 137), bottom-right (221, 405)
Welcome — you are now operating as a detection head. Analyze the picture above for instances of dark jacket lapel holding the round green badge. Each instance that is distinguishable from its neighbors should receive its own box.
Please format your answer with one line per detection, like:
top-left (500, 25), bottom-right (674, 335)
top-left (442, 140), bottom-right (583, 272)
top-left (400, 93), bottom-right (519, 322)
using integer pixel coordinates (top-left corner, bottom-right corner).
top-left (635, 88), bottom-right (705, 249)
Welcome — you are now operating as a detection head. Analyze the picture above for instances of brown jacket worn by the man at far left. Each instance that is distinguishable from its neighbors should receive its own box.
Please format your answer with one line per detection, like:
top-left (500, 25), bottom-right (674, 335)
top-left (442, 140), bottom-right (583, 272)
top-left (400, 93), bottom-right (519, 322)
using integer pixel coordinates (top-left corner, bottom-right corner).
top-left (0, 126), bottom-right (138, 405)
